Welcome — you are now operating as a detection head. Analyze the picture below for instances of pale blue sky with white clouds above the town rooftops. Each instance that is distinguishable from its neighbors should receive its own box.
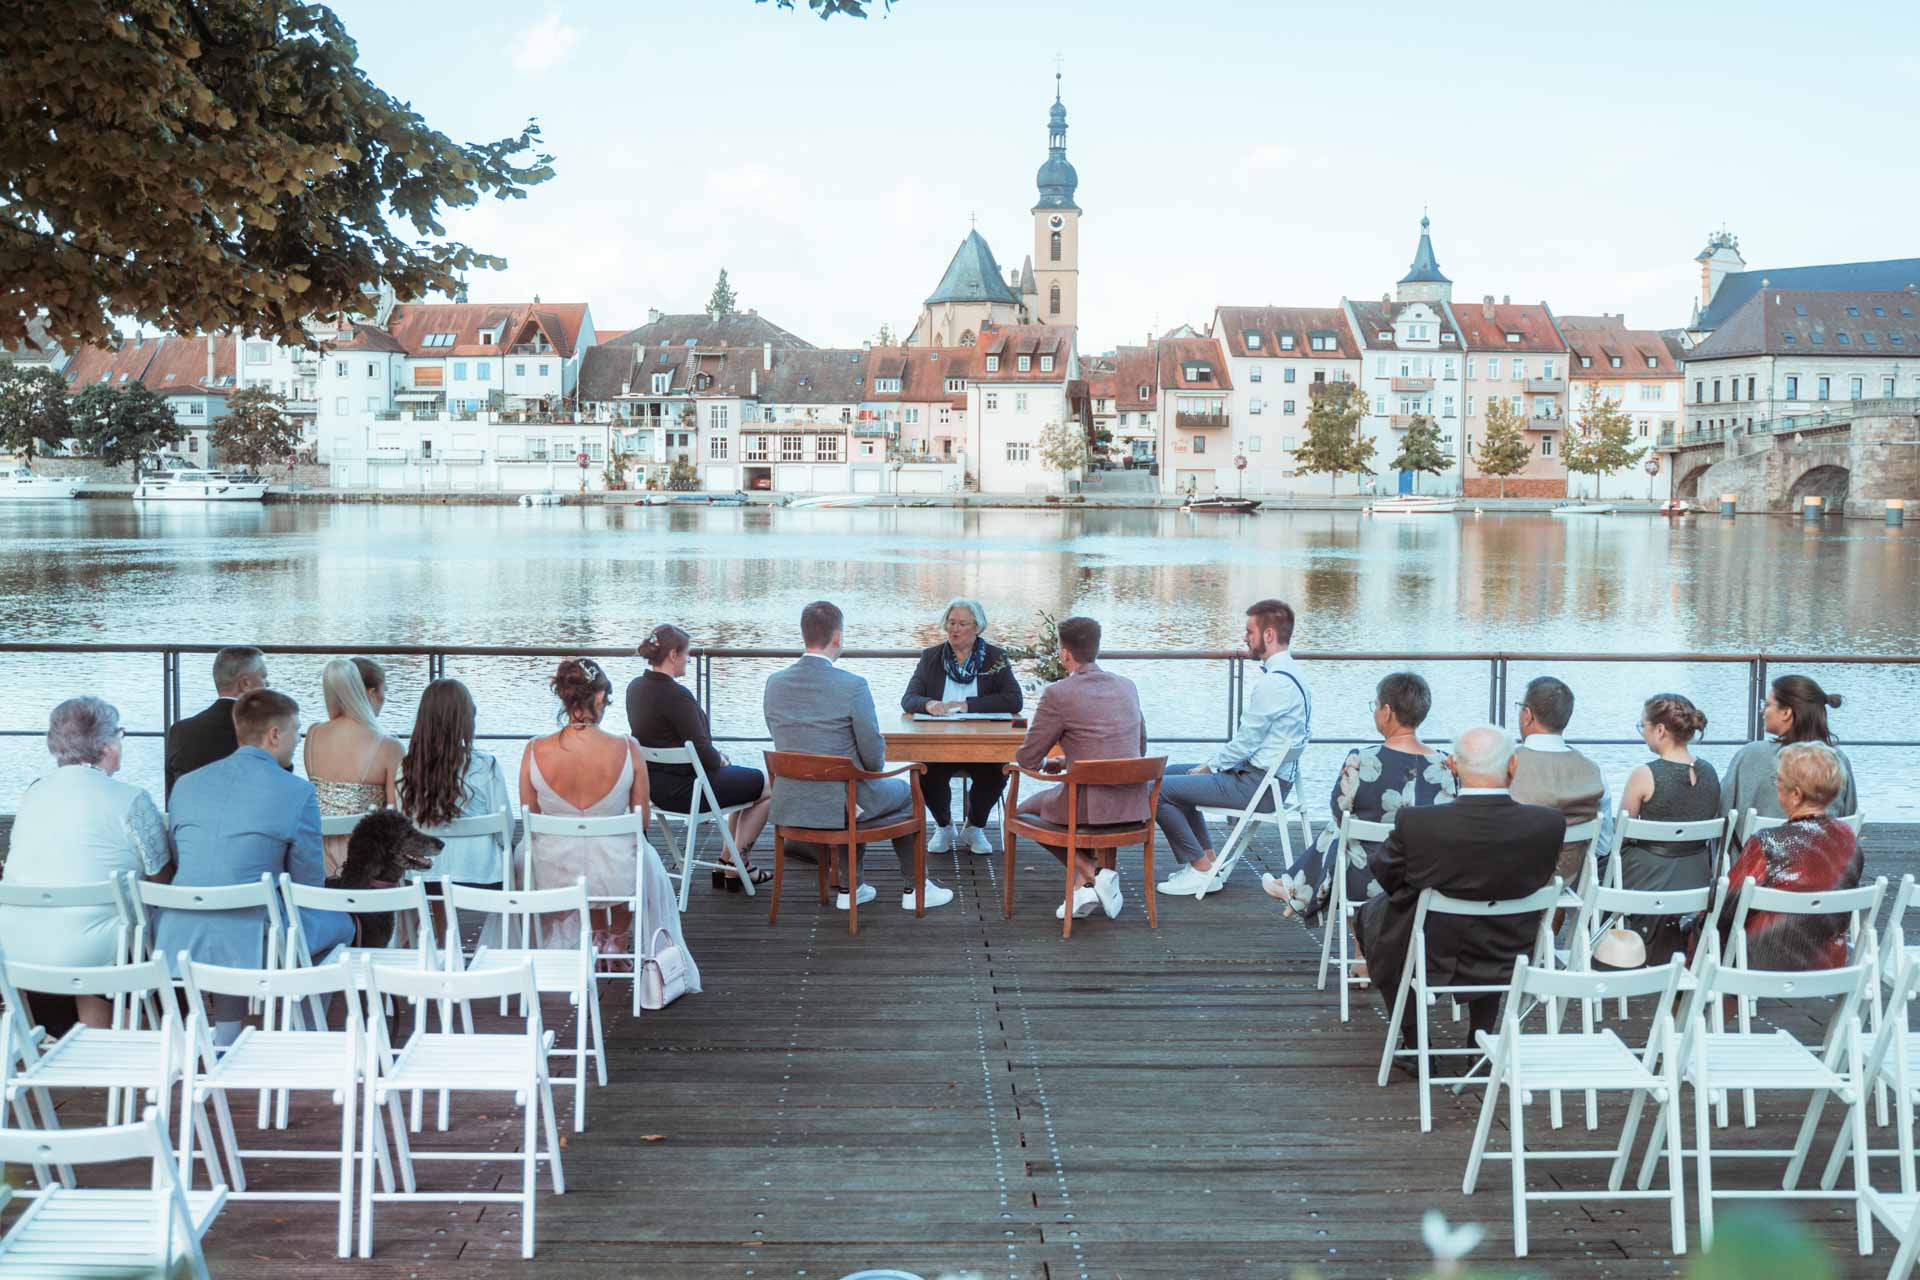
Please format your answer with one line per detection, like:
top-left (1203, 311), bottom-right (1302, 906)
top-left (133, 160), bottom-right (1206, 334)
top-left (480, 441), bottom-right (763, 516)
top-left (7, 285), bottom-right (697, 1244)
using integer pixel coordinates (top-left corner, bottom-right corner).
top-left (332, 0), bottom-right (1920, 353)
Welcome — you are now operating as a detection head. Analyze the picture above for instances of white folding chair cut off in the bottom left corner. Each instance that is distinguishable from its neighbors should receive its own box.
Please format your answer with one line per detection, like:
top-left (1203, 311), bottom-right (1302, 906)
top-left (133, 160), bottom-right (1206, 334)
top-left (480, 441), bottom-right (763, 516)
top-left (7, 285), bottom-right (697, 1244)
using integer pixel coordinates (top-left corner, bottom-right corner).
top-left (0, 1109), bottom-right (227, 1280)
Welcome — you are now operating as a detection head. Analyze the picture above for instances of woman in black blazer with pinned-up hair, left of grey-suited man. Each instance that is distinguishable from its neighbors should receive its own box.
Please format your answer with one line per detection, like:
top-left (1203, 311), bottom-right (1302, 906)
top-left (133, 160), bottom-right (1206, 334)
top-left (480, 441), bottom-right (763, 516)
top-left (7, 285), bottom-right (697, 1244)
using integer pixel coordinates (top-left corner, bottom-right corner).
top-left (626, 624), bottom-right (774, 890)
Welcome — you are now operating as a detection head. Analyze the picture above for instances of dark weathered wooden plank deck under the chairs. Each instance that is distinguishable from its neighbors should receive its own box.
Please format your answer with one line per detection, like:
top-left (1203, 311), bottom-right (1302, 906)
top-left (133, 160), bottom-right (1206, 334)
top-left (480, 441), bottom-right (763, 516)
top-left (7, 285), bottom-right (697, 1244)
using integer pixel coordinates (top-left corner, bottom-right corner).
top-left (13, 827), bottom-right (1920, 1280)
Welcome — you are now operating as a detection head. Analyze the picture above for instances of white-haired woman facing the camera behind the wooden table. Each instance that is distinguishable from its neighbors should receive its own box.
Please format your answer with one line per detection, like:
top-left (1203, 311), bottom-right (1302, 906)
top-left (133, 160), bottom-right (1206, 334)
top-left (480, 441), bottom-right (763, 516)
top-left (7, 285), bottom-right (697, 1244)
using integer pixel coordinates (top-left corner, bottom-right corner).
top-left (900, 599), bottom-right (1021, 854)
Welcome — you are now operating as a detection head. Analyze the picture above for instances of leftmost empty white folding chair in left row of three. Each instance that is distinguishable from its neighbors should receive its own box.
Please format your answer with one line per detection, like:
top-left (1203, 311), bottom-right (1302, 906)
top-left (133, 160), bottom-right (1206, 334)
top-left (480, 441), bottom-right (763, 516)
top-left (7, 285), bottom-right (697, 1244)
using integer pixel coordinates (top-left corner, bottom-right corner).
top-left (0, 954), bottom-right (217, 1186)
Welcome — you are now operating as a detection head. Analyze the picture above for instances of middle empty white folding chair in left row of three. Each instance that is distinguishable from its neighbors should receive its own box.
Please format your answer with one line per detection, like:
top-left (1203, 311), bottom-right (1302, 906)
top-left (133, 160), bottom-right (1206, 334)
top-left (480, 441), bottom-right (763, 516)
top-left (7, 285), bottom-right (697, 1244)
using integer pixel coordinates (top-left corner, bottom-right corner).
top-left (179, 952), bottom-right (394, 1257)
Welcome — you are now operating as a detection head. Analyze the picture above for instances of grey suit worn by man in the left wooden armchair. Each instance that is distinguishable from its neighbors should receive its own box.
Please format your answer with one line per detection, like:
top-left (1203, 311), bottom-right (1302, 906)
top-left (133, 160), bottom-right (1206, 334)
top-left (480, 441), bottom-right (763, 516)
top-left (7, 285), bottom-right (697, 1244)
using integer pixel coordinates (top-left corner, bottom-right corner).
top-left (762, 654), bottom-right (914, 889)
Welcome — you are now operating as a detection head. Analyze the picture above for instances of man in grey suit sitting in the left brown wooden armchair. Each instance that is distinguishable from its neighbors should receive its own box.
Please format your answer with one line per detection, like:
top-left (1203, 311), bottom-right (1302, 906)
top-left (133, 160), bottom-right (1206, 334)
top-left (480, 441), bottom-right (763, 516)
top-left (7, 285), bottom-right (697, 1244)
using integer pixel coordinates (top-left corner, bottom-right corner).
top-left (762, 601), bottom-right (954, 912)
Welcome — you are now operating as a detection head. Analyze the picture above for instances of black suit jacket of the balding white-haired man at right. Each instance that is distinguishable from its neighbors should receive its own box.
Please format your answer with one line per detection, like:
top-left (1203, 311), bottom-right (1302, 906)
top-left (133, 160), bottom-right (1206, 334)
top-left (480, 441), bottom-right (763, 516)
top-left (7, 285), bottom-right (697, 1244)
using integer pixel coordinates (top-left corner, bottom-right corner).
top-left (1359, 794), bottom-right (1567, 1007)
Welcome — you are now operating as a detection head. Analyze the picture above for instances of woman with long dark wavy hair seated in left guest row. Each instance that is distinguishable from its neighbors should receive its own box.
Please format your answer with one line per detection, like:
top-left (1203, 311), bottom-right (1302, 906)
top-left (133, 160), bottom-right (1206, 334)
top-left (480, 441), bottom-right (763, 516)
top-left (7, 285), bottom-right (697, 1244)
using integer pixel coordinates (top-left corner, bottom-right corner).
top-left (394, 679), bottom-right (509, 889)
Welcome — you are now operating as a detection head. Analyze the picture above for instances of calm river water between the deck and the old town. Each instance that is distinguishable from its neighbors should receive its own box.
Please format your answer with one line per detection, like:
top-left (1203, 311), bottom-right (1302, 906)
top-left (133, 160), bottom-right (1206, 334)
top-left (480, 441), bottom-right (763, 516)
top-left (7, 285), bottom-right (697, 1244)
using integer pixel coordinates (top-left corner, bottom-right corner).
top-left (0, 501), bottom-right (1920, 818)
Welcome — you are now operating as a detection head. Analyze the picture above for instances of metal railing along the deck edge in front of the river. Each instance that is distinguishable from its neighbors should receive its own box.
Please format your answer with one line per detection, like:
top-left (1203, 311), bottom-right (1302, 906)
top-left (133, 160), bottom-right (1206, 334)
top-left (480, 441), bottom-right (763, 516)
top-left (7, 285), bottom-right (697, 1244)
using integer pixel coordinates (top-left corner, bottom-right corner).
top-left (0, 641), bottom-right (1920, 747)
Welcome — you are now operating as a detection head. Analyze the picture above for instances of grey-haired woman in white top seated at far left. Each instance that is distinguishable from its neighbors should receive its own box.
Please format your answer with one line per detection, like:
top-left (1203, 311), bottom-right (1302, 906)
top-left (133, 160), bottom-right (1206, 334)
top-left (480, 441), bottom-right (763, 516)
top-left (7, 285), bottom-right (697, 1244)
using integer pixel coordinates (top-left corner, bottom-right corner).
top-left (0, 699), bottom-right (173, 1027)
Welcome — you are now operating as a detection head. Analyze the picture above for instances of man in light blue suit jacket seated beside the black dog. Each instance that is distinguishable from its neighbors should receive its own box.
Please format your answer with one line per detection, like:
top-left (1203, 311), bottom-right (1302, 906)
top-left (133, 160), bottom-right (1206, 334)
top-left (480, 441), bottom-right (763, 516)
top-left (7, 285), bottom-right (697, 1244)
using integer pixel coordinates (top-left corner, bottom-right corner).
top-left (154, 690), bottom-right (353, 1044)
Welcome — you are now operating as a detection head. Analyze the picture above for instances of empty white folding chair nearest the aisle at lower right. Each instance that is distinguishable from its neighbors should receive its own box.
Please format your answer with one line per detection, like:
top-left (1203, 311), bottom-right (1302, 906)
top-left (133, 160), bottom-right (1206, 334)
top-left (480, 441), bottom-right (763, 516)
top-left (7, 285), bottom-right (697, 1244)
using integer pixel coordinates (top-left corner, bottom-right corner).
top-left (1459, 956), bottom-right (1686, 1257)
